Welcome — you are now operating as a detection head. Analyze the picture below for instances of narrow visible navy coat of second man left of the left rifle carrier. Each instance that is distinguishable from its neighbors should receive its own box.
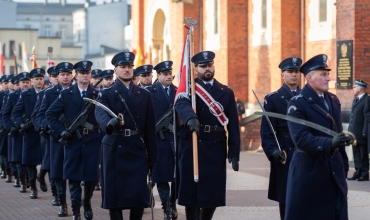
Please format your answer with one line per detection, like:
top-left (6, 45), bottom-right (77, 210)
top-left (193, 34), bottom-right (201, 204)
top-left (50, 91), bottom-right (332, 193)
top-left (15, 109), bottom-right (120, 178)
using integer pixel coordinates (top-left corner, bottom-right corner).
top-left (31, 88), bottom-right (50, 170)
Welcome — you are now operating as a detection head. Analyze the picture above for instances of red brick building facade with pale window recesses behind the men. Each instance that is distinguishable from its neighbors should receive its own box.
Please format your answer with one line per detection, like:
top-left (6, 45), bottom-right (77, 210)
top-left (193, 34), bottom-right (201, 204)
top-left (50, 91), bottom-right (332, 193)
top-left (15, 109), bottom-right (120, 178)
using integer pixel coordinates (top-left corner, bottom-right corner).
top-left (132, 0), bottom-right (370, 150)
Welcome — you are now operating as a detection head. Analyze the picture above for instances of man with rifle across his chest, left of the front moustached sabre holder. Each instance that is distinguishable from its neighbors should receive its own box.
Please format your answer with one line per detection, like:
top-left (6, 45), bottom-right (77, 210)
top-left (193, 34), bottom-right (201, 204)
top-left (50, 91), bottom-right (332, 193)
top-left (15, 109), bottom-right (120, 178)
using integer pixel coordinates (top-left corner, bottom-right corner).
top-left (45, 61), bottom-right (100, 219)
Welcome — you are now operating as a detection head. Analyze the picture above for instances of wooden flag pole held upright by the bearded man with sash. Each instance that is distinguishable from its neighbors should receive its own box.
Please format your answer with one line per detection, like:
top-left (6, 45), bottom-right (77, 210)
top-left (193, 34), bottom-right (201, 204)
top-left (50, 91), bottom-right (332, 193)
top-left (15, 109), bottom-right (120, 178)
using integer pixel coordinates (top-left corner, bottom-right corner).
top-left (185, 18), bottom-right (199, 183)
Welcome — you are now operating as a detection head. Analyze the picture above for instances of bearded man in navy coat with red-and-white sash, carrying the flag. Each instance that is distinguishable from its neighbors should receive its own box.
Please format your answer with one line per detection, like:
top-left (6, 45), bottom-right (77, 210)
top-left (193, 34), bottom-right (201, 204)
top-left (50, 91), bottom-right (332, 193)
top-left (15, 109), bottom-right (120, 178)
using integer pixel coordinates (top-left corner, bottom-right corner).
top-left (175, 51), bottom-right (240, 219)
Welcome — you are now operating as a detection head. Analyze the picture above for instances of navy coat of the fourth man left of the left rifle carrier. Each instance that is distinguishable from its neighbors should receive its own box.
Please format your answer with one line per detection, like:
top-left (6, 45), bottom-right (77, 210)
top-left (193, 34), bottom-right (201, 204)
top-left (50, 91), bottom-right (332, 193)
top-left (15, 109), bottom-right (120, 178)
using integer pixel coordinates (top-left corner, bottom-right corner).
top-left (3, 89), bottom-right (23, 163)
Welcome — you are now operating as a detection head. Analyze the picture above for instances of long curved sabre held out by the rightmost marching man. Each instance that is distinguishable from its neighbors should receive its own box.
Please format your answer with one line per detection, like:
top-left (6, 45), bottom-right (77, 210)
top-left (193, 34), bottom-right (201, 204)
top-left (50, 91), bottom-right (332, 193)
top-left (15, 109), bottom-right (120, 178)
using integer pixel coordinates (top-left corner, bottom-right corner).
top-left (254, 112), bottom-right (357, 146)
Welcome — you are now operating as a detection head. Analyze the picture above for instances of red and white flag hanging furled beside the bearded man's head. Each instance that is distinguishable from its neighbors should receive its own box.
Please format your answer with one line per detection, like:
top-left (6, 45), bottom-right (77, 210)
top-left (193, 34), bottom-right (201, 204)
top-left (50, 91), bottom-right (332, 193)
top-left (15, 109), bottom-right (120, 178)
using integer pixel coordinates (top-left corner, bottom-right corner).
top-left (175, 27), bottom-right (191, 101)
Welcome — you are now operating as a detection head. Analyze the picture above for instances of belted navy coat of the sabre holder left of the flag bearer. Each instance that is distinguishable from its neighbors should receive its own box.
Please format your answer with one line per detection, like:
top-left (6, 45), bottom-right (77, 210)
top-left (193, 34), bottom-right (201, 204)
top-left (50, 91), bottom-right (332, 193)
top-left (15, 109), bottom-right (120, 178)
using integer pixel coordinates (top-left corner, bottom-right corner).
top-left (95, 80), bottom-right (157, 209)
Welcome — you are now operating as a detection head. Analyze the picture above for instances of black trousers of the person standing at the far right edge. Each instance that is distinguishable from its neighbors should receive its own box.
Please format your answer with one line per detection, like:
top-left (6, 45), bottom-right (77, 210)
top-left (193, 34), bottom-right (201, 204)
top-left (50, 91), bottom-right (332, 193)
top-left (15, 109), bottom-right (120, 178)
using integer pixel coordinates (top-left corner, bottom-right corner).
top-left (352, 144), bottom-right (369, 176)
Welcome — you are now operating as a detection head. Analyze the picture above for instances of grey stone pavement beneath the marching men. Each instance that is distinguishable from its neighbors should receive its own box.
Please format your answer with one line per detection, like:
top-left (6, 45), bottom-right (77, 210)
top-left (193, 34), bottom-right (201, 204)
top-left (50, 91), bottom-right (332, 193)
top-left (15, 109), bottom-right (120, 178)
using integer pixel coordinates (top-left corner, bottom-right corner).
top-left (0, 152), bottom-right (370, 220)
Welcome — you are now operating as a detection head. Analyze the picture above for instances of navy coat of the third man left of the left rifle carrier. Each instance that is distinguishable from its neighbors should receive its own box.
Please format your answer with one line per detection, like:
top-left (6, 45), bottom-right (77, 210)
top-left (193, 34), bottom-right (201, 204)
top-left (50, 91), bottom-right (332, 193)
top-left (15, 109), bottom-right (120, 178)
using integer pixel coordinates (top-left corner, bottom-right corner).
top-left (12, 88), bottom-right (41, 165)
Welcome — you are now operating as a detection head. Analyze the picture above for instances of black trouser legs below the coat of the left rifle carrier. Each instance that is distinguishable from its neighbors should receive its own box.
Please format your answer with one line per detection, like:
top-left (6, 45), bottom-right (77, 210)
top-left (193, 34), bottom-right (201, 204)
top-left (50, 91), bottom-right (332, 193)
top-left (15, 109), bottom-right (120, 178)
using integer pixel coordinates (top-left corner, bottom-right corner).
top-left (68, 180), bottom-right (95, 205)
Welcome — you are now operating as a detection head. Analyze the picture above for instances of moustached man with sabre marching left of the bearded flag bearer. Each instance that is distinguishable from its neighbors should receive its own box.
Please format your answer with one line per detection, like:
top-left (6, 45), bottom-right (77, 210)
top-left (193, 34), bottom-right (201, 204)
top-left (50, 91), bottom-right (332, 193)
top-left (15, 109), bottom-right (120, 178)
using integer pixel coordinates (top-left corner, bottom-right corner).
top-left (95, 52), bottom-right (157, 220)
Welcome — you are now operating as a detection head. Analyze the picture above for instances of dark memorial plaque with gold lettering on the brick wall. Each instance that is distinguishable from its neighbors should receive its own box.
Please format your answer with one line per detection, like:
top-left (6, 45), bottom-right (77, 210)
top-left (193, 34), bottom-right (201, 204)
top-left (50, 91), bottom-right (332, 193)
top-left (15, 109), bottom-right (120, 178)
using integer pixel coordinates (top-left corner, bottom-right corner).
top-left (337, 40), bottom-right (353, 89)
